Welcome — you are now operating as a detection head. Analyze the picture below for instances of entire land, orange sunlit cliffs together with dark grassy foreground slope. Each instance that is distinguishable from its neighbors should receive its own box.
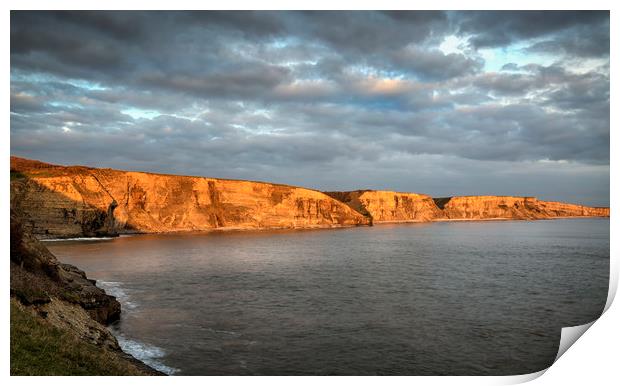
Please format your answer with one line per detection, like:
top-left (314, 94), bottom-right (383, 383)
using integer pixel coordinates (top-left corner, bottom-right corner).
top-left (10, 157), bottom-right (609, 375)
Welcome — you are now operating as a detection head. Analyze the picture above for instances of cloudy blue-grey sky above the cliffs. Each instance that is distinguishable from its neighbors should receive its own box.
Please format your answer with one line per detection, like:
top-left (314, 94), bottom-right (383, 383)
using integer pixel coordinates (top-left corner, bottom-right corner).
top-left (10, 11), bottom-right (610, 205)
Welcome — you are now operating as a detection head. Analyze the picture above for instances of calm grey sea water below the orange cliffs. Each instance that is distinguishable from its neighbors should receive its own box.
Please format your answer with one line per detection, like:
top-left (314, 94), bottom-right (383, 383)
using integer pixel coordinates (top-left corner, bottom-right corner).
top-left (47, 219), bottom-right (609, 375)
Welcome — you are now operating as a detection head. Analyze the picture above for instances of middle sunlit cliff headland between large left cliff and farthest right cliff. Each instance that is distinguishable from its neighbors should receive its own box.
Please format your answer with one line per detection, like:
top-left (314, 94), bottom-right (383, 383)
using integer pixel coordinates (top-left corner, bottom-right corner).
top-left (326, 190), bottom-right (441, 223)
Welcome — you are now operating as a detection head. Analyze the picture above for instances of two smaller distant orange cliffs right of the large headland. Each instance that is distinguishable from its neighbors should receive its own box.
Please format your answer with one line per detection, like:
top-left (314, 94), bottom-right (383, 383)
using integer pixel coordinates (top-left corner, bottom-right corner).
top-left (327, 190), bottom-right (609, 223)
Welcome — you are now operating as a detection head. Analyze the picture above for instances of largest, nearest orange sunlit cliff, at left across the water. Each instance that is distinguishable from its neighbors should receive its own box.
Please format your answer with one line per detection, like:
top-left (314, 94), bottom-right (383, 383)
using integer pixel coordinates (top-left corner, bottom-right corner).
top-left (11, 157), bottom-right (370, 237)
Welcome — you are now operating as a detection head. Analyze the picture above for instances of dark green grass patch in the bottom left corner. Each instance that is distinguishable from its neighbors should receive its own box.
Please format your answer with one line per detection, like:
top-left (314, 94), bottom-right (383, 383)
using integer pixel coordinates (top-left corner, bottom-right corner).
top-left (11, 299), bottom-right (144, 375)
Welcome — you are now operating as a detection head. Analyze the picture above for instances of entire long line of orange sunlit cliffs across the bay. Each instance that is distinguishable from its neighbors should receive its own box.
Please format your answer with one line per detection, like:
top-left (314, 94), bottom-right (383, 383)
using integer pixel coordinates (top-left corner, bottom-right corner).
top-left (11, 157), bottom-right (609, 238)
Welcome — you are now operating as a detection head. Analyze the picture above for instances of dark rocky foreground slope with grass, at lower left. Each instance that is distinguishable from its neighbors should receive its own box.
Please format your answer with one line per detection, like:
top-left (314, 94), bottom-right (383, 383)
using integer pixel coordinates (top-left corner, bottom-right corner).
top-left (10, 212), bottom-right (161, 375)
